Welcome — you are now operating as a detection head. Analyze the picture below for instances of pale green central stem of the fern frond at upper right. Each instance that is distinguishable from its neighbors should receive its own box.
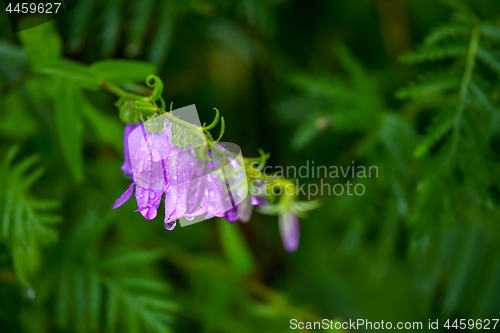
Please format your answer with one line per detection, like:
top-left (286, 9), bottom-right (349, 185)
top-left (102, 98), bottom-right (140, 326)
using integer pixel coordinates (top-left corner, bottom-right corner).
top-left (450, 25), bottom-right (481, 158)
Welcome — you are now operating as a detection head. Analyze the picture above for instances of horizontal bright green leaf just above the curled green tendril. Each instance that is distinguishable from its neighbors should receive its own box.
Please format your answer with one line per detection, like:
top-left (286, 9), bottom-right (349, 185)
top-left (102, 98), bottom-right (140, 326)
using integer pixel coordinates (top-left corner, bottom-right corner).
top-left (90, 60), bottom-right (156, 85)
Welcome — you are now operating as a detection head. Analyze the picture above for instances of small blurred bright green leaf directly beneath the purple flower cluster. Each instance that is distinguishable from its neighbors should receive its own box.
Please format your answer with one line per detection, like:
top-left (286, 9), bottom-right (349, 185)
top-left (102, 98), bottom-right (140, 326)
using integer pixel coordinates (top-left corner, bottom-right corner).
top-left (218, 219), bottom-right (255, 275)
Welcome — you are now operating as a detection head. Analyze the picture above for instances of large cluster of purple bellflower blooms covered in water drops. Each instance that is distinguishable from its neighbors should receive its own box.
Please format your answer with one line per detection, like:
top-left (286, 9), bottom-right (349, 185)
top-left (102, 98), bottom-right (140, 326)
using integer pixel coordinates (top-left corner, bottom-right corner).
top-left (113, 120), bottom-right (237, 230)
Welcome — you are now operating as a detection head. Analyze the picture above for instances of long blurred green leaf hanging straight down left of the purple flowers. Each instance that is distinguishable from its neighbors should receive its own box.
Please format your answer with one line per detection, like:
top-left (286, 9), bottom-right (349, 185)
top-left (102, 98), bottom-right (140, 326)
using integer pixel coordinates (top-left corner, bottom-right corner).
top-left (55, 79), bottom-right (84, 181)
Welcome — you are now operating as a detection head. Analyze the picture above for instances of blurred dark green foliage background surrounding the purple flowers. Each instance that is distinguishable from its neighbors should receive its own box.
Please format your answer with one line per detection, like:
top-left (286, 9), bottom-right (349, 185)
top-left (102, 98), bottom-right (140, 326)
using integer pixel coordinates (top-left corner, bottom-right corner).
top-left (0, 0), bottom-right (500, 333)
